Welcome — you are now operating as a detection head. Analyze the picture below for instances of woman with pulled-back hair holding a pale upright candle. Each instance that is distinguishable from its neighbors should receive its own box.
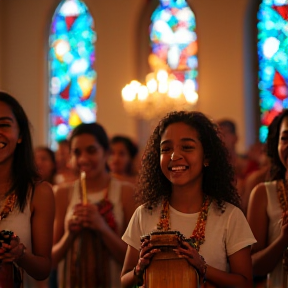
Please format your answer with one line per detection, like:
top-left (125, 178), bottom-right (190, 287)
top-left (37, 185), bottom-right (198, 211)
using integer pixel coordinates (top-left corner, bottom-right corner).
top-left (52, 123), bottom-right (135, 288)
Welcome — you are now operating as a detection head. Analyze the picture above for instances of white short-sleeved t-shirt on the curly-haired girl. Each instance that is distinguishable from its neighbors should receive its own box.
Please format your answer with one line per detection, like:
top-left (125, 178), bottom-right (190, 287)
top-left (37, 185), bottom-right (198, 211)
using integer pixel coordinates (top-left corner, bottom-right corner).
top-left (122, 203), bottom-right (256, 271)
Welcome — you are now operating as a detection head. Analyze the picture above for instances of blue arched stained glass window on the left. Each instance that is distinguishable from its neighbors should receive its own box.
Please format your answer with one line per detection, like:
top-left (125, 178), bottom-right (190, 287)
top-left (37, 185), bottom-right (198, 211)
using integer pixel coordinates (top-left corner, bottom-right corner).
top-left (49, 0), bottom-right (97, 149)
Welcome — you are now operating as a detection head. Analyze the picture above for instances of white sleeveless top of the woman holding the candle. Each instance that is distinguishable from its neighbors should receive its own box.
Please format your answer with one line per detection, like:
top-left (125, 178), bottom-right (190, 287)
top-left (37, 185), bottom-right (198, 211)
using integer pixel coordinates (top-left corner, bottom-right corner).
top-left (58, 178), bottom-right (127, 288)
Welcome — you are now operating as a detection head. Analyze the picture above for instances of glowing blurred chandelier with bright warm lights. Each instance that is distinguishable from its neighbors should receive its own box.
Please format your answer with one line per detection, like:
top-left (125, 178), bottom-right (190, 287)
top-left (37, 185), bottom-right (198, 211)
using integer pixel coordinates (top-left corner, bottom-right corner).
top-left (122, 69), bottom-right (198, 120)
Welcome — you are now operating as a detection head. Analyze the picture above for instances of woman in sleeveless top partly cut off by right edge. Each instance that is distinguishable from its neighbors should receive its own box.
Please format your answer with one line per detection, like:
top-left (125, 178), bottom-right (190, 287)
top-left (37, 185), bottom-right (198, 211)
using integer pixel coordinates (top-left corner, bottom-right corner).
top-left (247, 109), bottom-right (288, 288)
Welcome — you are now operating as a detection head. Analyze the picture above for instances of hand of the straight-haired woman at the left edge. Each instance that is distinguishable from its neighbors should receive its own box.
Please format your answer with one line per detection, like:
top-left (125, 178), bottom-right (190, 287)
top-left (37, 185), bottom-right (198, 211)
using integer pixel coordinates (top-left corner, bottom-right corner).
top-left (0, 236), bottom-right (26, 263)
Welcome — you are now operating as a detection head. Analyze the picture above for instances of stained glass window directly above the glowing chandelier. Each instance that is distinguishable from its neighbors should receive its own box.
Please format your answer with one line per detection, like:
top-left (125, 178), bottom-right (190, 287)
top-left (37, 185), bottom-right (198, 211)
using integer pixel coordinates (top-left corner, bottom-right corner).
top-left (149, 0), bottom-right (198, 90)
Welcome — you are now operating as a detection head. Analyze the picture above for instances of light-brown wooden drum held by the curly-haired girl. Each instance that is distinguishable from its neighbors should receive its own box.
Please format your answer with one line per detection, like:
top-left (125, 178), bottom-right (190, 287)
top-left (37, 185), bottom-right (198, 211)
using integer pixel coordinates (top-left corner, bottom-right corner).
top-left (142, 231), bottom-right (199, 288)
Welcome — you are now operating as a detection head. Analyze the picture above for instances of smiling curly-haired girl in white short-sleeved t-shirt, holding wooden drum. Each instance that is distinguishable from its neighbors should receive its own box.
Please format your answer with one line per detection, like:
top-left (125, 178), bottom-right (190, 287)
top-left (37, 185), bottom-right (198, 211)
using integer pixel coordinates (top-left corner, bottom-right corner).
top-left (121, 111), bottom-right (255, 288)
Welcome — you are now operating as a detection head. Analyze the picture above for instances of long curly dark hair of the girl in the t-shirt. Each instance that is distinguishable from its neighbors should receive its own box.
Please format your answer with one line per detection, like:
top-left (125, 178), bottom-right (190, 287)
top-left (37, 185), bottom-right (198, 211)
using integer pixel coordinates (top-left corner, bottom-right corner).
top-left (136, 111), bottom-right (240, 210)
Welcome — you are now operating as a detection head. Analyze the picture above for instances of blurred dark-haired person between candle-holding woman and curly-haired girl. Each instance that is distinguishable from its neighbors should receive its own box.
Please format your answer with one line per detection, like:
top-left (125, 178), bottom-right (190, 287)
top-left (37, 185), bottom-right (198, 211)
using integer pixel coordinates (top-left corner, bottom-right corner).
top-left (108, 135), bottom-right (138, 183)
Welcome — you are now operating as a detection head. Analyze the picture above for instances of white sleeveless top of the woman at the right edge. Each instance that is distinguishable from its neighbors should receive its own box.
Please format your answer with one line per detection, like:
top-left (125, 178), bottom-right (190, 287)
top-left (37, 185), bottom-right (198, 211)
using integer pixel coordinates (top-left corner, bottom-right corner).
top-left (265, 181), bottom-right (283, 288)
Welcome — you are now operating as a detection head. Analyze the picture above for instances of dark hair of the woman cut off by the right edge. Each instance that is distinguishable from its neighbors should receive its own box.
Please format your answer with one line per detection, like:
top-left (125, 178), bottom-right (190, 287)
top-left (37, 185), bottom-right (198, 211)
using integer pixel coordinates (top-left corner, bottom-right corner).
top-left (267, 109), bottom-right (288, 181)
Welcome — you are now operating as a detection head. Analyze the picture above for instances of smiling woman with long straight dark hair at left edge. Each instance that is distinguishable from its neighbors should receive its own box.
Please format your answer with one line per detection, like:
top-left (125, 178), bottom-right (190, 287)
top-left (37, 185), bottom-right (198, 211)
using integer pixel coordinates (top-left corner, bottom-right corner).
top-left (0, 92), bottom-right (55, 288)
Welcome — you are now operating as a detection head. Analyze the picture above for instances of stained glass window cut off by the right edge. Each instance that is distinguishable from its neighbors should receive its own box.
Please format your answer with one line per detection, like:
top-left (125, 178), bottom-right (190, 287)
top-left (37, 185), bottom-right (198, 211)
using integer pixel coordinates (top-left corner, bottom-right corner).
top-left (257, 0), bottom-right (288, 142)
